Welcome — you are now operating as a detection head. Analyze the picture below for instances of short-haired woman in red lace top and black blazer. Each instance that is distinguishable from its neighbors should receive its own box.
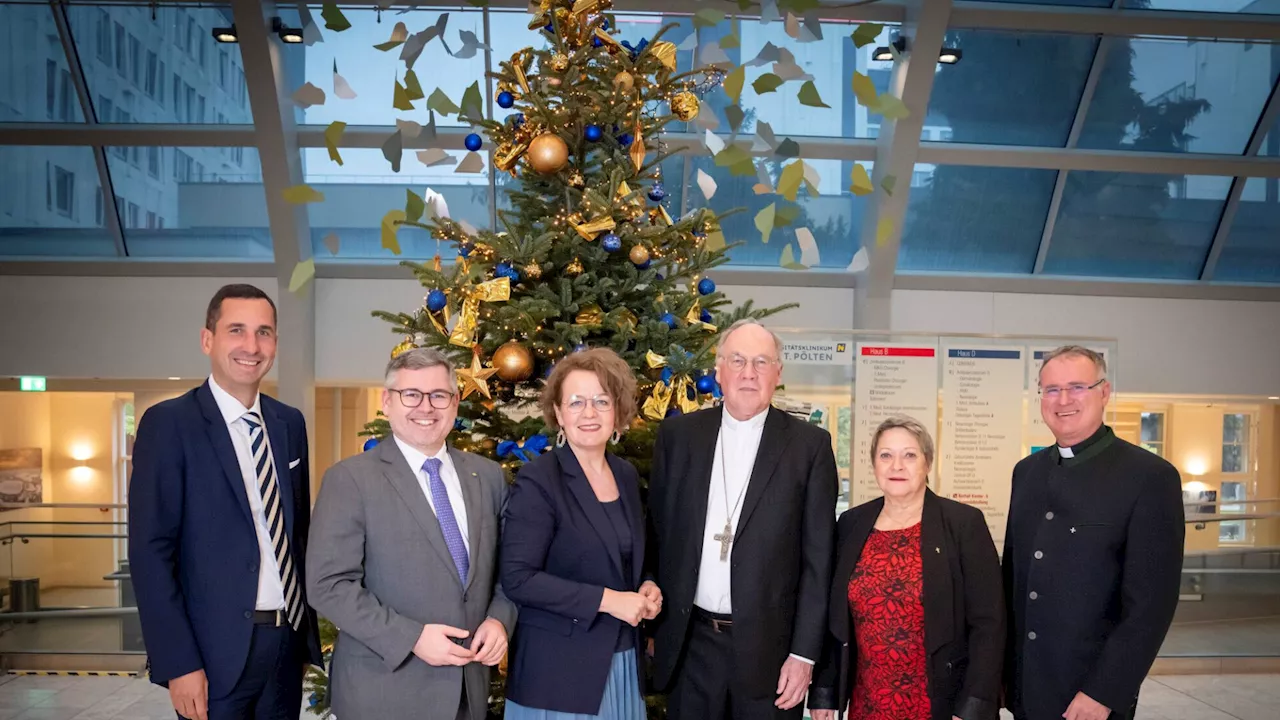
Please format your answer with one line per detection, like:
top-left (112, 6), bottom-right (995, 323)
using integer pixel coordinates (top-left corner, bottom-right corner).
top-left (809, 418), bottom-right (1005, 720)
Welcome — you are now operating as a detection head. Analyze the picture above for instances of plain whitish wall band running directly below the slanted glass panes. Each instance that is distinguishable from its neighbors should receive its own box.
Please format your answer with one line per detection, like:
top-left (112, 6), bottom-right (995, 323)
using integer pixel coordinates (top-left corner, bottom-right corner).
top-left (0, 275), bottom-right (1280, 396)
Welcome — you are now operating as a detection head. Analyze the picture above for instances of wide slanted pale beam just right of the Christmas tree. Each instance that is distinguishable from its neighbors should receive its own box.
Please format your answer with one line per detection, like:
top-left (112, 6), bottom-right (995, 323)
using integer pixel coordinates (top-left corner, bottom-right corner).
top-left (854, 0), bottom-right (951, 329)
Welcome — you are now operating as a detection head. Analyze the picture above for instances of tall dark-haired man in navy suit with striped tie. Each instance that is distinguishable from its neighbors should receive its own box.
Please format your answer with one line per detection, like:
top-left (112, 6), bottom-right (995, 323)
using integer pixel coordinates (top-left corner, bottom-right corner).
top-left (129, 284), bottom-right (323, 720)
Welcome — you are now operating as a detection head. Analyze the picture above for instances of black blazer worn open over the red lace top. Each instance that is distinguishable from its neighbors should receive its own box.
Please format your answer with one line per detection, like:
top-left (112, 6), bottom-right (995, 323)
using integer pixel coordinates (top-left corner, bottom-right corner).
top-left (809, 489), bottom-right (1005, 720)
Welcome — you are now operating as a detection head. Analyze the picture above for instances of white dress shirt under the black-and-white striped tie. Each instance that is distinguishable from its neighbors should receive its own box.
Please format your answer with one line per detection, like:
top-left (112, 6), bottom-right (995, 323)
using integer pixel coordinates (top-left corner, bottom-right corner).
top-left (209, 375), bottom-right (288, 610)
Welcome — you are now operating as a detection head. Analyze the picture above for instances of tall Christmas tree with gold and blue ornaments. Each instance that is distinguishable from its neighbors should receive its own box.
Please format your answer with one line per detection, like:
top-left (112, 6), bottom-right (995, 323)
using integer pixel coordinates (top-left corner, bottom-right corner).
top-left (308, 0), bottom-right (791, 715)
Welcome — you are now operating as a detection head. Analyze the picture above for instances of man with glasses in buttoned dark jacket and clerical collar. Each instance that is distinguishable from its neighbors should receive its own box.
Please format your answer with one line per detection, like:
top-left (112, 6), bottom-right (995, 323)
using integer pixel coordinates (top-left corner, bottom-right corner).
top-left (1004, 346), bottom-right (1185, 720)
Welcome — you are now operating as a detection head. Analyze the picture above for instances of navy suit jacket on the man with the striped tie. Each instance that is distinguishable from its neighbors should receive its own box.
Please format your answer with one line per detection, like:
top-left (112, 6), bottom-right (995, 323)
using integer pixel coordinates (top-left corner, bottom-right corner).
top-left (129, 380), bottom-right (323, 698)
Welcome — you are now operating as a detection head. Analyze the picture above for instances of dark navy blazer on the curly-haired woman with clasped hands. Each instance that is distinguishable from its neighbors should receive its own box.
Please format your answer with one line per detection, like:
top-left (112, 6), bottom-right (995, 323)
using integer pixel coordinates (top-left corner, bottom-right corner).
top-left (500, 447), bottom-right (645, 715)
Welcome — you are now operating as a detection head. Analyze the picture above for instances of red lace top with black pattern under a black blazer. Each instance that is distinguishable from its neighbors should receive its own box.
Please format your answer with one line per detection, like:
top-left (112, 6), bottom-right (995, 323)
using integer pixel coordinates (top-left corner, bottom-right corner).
top-left (849, 524), bottom-right (929, 720)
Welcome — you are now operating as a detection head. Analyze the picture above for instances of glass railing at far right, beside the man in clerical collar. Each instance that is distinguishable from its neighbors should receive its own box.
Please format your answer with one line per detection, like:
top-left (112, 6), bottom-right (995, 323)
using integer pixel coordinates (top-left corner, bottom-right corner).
top-left (1160, 500), bottom-right (1280, 657)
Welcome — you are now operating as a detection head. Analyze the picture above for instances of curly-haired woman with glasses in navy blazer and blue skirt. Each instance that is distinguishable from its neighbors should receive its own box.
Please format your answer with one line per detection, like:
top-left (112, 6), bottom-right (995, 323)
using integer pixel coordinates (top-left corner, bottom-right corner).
top-left (500, 348), bottom-right (662, 720)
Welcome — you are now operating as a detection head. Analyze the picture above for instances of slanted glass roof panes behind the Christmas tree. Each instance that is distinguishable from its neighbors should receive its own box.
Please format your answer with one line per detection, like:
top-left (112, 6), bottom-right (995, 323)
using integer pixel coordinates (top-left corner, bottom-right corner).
top-left (0, 0), bottom-right (1280, 284)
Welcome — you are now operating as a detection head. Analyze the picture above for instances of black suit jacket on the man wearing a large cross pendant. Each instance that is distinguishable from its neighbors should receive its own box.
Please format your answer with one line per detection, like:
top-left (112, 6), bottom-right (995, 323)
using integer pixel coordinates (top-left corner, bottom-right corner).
top-left (648, 407), bottom-right (837, 698)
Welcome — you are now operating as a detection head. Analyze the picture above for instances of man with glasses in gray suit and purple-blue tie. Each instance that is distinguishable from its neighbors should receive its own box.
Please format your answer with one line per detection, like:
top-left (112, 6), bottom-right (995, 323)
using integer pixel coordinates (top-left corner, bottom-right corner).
top-left (307, 348), bottom-right (516, 720)
